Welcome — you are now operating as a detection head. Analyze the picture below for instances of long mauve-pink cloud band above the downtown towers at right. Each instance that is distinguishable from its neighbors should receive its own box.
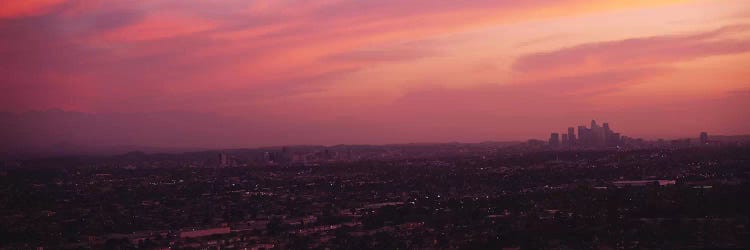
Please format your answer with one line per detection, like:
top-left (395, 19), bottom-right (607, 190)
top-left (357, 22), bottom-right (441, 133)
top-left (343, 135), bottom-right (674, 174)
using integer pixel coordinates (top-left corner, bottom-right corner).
top-left (513, 25), bottom-right (750, 75)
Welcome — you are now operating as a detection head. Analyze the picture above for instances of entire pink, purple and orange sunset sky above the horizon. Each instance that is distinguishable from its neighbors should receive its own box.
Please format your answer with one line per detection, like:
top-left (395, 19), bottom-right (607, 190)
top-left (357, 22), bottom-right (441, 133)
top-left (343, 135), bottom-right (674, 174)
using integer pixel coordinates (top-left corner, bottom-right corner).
top-left (0, 0), bottom-right (750, 148)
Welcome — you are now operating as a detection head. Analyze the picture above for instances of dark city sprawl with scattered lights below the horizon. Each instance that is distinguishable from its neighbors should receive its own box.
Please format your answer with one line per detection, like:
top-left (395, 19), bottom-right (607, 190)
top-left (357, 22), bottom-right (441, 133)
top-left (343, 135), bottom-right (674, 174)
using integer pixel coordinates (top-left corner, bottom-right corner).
top-left (0, 146), bottom-right (750, 249)
